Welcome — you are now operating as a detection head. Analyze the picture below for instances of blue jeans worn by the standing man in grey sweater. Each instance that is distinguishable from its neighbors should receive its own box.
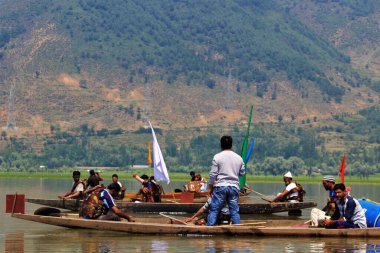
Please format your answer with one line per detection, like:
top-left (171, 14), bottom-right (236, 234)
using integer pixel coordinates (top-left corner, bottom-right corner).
top-left (207, 186), bottom-right (240, 226)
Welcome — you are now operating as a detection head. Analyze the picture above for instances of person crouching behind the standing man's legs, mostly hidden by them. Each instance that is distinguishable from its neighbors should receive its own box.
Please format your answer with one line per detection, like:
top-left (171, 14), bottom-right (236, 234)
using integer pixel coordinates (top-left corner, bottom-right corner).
top-left (185, 188), bottom-right (231, 225)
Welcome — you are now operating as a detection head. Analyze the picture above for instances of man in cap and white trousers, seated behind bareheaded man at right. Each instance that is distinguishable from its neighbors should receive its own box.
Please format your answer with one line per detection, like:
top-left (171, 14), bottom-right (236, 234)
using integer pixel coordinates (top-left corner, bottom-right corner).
top-left (310, 175), bottom-right (337, 227)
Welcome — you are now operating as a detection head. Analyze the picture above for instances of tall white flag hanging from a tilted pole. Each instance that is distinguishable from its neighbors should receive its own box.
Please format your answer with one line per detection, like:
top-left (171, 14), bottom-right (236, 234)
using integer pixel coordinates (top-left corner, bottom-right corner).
top-left (148, 121), bottom-right (170, 184)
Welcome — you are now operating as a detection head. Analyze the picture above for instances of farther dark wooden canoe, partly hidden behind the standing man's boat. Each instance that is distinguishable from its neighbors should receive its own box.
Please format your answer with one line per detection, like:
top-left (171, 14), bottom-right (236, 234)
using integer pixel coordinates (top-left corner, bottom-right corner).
top-left (26, 198), bottom-right (317, 214)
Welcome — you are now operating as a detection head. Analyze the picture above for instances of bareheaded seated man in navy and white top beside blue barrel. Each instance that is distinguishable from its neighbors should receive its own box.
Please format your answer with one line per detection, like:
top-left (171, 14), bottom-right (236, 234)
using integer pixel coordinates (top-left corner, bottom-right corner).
top-left (323, 184), bottom-right (367, 228)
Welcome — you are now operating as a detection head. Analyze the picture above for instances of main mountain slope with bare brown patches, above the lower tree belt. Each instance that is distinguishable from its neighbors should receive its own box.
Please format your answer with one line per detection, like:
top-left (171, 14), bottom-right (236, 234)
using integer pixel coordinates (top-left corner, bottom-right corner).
top-left (0, 0), bottom-right (379, 132)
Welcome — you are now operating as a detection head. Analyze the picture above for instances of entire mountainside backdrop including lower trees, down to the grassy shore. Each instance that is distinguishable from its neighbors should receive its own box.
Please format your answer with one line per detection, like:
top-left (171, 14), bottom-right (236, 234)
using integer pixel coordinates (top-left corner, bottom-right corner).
top-left (0, 0), bottom-right (380, 174)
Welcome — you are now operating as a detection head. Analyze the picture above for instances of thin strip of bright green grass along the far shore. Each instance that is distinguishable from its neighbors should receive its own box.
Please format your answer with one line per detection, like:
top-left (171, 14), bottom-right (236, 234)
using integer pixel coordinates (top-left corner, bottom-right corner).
top-left (0, 170), bottom-right (380, 184)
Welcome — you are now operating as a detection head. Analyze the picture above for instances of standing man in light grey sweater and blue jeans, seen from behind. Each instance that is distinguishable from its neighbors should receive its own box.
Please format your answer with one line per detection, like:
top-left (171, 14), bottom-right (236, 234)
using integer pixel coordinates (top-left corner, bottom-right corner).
top-left (207, 136), bottom-right (245, 226)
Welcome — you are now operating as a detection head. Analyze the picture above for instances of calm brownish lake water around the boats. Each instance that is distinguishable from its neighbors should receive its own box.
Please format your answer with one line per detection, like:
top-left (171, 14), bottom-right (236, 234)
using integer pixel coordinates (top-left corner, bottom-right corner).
top-left (0, 179), bottom-right (380, 253)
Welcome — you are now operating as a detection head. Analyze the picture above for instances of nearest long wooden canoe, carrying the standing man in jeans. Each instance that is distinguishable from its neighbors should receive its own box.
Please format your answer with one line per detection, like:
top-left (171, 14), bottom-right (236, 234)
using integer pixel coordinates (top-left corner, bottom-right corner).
top-left (13, 214), bottom-right (380, 238)
